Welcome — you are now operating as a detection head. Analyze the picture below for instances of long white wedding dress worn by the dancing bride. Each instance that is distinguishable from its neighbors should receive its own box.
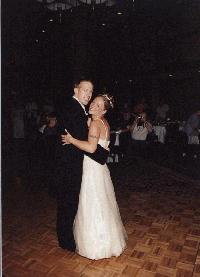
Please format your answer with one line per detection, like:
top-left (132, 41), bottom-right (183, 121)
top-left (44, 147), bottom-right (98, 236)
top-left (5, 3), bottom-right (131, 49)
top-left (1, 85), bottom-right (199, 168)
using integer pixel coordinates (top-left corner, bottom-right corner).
top-left (74, 121), bottom-right (127, 260)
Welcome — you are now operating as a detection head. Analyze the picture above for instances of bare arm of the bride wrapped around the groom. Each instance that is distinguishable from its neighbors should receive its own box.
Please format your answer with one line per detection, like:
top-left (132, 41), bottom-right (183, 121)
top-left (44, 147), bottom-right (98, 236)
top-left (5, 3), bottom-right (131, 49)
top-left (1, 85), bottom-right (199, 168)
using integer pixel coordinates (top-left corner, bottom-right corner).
top-left (67, 121), bottom-right (100, 153)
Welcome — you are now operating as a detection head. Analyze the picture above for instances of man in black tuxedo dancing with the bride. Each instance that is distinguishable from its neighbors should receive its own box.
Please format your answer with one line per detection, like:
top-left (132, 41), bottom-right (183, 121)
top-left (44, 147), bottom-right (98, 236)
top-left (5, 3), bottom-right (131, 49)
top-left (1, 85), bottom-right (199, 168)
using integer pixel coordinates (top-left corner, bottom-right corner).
top-left (55, 79), bottom-right (108, 251)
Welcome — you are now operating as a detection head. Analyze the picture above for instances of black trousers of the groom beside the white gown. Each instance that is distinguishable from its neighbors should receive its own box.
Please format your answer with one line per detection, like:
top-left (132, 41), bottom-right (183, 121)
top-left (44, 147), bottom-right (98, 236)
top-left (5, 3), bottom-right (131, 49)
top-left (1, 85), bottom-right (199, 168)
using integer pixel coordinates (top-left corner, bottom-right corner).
top-left (57, 165), bottom-right (82, 251)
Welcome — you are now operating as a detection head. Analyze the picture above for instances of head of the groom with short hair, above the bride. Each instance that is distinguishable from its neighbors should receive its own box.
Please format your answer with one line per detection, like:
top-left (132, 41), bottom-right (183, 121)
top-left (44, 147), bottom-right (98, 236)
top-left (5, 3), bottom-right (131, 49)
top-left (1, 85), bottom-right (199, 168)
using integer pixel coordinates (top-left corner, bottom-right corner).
top-left (74, 81), bottom-right (93, 106)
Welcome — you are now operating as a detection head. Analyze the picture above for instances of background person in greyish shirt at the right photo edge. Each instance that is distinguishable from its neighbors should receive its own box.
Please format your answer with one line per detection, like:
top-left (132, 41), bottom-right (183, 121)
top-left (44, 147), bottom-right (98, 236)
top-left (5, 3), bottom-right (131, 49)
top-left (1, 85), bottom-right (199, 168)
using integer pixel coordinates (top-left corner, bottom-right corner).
top-left (183, 110), bottom-right (200, 144)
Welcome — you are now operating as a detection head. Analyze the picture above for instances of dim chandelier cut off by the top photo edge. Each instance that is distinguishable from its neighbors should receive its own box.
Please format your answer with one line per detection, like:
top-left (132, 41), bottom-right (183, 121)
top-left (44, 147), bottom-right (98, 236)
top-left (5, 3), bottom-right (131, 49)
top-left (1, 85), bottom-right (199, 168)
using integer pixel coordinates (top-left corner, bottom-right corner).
top-left (37, 0), bottom-right (116, 11)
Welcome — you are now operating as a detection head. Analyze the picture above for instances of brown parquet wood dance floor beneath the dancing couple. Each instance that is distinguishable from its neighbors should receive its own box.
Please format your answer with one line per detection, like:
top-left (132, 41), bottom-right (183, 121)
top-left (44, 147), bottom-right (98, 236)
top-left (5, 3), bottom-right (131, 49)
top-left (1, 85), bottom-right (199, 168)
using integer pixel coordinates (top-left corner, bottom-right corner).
top-left (2, 157), bottom-right (200, 277)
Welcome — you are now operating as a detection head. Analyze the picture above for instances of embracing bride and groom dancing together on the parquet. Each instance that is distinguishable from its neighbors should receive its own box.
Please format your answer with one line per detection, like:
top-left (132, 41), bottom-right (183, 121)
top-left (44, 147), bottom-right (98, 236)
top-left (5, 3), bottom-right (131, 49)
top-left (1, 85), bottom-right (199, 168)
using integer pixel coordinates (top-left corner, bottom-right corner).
top-left (56, 80), bottom-right (127, 260)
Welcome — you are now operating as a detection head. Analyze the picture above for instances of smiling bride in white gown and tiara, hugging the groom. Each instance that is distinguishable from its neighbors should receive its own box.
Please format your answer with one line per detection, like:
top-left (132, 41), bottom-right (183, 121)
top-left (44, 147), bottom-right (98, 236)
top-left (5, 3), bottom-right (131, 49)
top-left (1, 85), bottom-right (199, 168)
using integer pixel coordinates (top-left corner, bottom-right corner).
top-left (65, 94), bottom-right (127, 260)
